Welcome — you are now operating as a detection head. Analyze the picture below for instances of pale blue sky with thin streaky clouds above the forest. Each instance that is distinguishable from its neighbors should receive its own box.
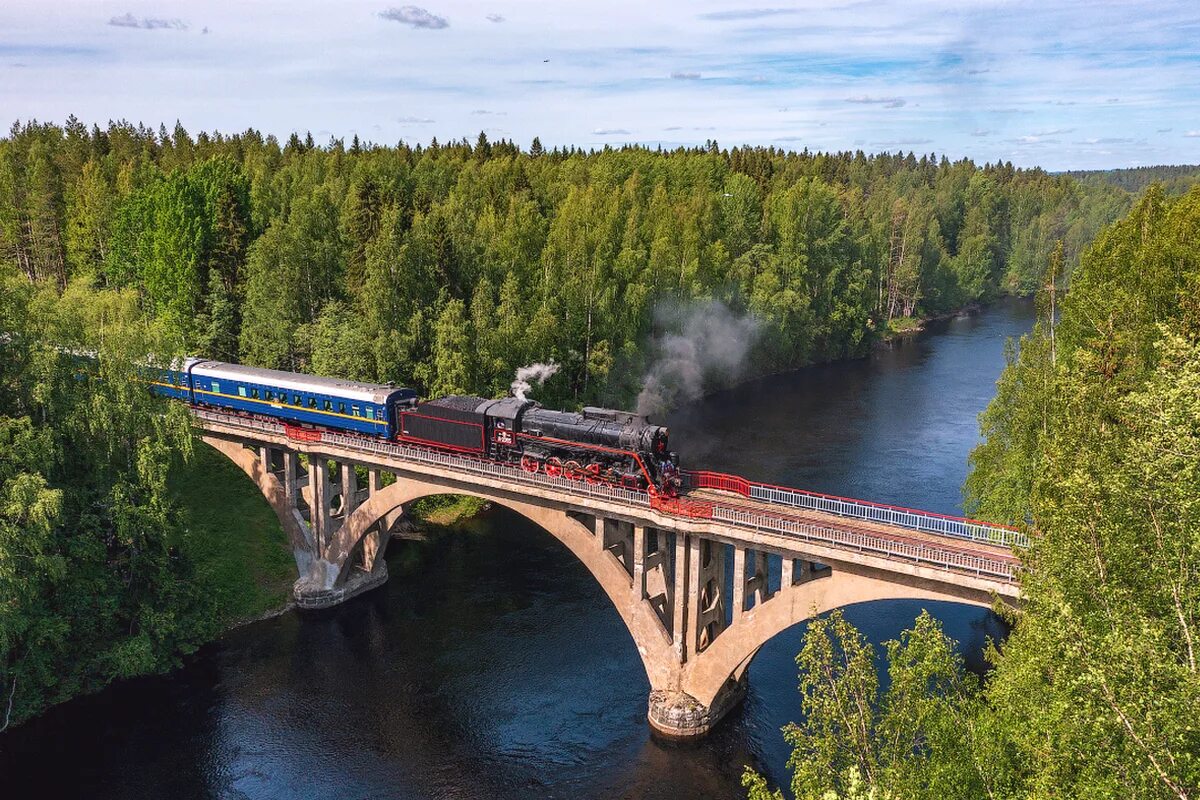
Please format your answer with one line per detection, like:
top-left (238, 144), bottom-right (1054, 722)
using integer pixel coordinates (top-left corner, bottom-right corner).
top-left (0, 0), bottom-right (1200, 170)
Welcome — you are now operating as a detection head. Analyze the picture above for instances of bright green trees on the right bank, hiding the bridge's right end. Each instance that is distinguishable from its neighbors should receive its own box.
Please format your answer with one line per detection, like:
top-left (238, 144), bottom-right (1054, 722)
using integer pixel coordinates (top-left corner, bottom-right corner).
top-left (745, 187), bottom-right (1200, 800)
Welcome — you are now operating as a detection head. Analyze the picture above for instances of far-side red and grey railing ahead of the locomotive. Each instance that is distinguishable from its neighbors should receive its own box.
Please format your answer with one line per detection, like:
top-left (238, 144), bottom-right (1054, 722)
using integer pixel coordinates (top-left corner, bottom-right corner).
top-left (683, 470), bottom-right (1030, 547)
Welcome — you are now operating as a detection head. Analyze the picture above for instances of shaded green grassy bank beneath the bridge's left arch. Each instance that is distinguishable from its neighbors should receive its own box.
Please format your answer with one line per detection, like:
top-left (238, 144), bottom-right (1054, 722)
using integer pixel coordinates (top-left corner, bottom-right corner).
top-left (170, 443), bottom-right (296, 627)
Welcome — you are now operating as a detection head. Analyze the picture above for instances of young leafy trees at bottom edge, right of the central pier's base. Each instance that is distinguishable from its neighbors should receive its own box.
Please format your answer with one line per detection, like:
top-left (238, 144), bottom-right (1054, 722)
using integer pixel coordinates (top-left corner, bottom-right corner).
top-left (743, 612), bottom-right (1009, 800)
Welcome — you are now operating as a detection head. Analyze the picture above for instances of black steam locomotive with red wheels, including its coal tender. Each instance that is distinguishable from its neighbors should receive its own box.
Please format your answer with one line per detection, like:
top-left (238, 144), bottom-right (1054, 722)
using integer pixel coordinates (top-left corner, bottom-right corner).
top-left (396, 396), bottom-right (679, 497)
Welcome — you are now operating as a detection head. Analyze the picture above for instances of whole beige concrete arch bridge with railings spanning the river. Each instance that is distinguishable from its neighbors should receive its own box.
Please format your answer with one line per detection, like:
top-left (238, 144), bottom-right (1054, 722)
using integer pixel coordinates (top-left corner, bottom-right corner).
top-left (194, 409), bottom-right (1025, 736)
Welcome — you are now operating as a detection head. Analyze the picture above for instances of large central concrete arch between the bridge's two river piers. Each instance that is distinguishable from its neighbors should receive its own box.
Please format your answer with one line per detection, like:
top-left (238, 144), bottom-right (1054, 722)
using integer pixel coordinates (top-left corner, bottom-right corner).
top-left (314, 476), bottom-right (673, 686)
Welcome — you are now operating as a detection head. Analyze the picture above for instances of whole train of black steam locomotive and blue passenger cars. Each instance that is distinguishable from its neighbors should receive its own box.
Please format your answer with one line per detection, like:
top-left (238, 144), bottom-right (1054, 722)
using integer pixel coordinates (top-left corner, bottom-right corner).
top-left (148, 359), bottom-right (680, 497)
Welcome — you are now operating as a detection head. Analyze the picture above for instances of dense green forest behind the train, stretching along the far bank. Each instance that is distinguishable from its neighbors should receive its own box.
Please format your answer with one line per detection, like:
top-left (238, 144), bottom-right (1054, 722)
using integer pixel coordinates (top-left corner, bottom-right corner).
top-left (0, 120), bottom-right (1129, 405)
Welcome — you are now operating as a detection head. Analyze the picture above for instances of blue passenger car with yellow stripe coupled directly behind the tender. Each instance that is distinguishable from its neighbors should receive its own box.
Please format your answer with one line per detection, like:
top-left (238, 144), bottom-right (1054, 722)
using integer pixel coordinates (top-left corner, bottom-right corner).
top-left (182, 360), bottom-right (416, 438)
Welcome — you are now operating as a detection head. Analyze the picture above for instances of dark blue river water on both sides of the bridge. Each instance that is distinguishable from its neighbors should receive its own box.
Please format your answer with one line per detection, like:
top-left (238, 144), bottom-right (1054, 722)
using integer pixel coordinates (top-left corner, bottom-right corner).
top-left (0, 301), bottom-right (1032, 800)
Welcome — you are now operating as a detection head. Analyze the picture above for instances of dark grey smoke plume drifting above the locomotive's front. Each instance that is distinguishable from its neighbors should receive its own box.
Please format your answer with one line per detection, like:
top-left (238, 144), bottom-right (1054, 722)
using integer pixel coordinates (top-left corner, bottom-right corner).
top-left (637, 301), bottom-right (762, 415)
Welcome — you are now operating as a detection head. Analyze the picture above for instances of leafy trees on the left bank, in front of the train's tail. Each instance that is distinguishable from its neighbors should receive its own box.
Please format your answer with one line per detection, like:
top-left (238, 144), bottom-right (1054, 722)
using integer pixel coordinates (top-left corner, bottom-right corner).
top-left (0, 269), bottom-right (226, 724)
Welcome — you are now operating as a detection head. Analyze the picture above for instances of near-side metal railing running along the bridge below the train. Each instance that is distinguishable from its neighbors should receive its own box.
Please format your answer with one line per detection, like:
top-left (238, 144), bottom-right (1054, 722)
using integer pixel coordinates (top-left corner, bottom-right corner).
top-left (193, 409), bottom-right (1016, 581)
